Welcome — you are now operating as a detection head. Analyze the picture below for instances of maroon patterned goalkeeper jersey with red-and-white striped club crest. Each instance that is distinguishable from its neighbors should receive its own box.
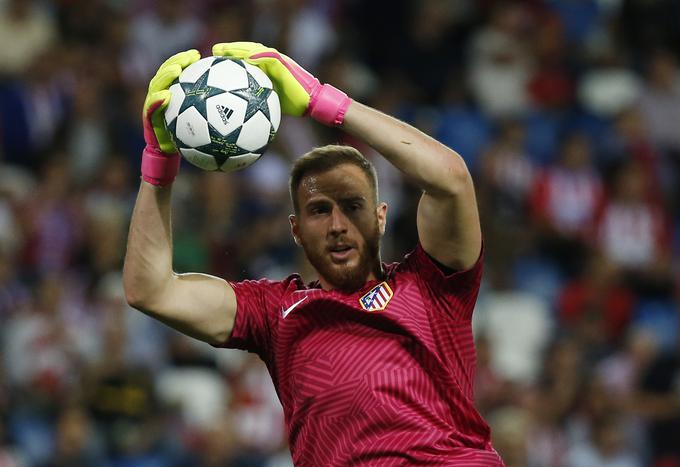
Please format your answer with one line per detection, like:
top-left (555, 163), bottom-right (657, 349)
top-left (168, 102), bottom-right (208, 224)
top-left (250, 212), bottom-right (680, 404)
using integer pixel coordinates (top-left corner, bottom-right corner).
top-left (223, 245), bottom-right (503, 467)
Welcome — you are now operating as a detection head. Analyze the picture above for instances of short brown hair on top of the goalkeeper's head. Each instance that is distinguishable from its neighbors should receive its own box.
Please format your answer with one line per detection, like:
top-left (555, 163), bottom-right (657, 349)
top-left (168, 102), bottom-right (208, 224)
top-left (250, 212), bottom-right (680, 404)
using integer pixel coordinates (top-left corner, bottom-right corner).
top-left (288, 144), bottom-right (378, 213)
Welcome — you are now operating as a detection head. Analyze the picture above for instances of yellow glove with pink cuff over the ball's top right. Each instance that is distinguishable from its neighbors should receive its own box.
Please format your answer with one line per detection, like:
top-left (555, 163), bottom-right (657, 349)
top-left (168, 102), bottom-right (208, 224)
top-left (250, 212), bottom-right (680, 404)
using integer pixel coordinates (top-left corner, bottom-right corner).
top-left (212, 42), bottom-right (352, 126)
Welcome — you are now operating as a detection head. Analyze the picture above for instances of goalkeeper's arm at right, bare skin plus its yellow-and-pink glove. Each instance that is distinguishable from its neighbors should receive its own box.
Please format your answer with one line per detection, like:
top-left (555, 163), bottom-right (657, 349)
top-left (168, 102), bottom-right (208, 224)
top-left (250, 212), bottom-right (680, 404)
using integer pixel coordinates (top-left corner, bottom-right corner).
top-left (213, 42), bottom-right (482, 270)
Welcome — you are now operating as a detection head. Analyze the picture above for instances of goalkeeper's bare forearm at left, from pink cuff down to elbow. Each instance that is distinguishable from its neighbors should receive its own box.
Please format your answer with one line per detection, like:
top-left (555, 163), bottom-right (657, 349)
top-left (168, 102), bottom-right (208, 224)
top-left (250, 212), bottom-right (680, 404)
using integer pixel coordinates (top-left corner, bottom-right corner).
top-left (123, 182), bottom-right (173, 309)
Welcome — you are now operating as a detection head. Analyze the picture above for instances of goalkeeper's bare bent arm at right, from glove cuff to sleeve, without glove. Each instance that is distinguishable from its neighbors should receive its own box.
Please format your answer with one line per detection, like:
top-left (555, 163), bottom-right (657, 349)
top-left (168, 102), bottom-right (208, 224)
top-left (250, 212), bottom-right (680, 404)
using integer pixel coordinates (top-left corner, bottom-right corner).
top-left (342, 102), bottom-right (482, 270)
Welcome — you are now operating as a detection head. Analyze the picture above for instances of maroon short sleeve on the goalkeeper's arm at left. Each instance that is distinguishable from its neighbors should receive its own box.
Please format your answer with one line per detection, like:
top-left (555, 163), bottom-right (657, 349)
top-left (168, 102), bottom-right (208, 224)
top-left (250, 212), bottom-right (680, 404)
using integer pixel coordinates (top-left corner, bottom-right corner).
top-left (212, 279), bottom-right (285, 360)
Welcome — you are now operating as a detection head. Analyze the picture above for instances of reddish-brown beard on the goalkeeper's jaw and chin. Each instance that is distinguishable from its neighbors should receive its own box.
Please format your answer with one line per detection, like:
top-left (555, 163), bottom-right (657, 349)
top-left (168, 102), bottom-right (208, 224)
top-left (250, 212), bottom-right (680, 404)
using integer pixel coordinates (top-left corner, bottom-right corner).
top-left (302, 222), bottom-right (380, 292)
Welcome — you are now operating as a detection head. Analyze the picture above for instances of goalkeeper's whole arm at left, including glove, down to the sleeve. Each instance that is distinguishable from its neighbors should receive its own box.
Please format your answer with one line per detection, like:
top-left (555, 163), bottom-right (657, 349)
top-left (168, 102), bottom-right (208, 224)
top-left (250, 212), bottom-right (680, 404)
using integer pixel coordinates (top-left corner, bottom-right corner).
top-left (123, 51), bottom-right (236, 344)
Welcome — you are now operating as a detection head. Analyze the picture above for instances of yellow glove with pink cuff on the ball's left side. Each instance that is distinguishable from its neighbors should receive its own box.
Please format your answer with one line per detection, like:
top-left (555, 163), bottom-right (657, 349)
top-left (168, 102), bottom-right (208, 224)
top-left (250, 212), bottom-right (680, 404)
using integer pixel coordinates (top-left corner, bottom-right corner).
top-left (142, 50), bottom-right (201, 186)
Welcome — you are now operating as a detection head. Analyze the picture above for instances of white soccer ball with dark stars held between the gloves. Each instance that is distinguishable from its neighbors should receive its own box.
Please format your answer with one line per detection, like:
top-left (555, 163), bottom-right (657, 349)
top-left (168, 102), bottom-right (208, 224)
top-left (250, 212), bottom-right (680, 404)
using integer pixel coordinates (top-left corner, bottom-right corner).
top-left (165, 57), bottom-right (281, 172)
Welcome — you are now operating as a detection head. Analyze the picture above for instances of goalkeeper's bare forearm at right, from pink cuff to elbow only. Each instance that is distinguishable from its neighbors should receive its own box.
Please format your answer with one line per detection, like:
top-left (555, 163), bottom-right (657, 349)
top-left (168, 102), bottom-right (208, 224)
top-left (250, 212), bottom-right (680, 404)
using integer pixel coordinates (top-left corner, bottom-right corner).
top-left (342, 101), bottom-right (470, 195)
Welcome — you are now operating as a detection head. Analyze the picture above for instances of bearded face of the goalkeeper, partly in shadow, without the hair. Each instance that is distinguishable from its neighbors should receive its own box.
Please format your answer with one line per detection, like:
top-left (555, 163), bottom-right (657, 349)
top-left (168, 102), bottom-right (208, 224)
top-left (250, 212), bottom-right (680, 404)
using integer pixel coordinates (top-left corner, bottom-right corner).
top-left (290, 164), bottom-right (387, 291)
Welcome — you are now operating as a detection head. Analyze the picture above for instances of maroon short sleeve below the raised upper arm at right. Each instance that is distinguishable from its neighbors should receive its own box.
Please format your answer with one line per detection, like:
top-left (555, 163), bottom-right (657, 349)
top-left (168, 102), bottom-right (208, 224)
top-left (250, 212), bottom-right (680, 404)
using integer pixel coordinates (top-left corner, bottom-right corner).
top-left (404, 243), bottom-right (484, 321)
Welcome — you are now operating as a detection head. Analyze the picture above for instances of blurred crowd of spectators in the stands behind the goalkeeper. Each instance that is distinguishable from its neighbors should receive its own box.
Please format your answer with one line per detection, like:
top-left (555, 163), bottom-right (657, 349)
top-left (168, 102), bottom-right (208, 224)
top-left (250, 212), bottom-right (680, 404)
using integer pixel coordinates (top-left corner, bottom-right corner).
top-left (0, 0), bottom-right (680, 467)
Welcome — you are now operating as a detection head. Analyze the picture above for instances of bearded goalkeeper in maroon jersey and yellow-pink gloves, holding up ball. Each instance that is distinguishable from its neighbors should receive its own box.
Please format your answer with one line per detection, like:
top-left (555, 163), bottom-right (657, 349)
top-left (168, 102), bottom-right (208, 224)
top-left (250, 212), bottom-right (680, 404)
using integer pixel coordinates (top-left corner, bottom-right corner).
top-left (124, 42), bottom-right (503, 466)
